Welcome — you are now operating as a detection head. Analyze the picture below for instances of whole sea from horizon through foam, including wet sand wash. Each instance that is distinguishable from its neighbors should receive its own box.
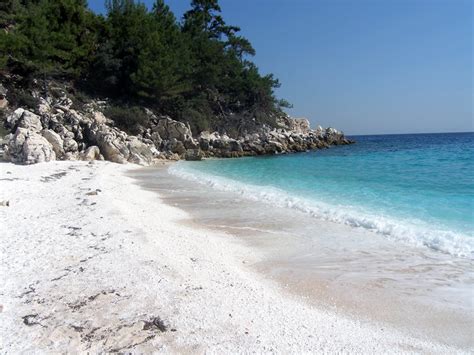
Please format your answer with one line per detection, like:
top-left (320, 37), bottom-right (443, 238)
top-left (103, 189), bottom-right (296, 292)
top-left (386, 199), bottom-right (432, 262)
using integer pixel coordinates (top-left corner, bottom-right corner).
top-left (132, 133), bottom-right (474, 351)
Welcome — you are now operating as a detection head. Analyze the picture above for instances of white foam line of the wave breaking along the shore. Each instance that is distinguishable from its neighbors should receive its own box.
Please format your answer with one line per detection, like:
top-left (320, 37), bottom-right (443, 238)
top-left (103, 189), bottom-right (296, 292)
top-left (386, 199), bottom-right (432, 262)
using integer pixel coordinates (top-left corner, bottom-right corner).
top-left (168, 162), bottom-right (474, 258)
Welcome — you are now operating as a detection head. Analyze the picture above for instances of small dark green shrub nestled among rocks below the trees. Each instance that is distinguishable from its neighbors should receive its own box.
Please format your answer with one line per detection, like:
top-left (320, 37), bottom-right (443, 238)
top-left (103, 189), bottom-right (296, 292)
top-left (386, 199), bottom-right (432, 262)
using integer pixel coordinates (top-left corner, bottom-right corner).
top-left (104, 106), bottom-right (148, 134)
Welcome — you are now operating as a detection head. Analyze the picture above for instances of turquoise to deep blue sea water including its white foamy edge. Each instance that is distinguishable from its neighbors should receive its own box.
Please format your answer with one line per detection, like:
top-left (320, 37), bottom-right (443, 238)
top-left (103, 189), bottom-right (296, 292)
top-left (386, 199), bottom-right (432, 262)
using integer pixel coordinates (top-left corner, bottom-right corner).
top-left (170, 133), bottom-right (474, 257)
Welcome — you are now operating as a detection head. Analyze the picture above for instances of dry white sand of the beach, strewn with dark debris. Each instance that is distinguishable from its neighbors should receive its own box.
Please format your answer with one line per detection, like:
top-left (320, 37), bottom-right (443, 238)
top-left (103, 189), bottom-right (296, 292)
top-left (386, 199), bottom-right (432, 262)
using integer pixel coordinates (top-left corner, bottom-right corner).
top-left (0, 162), bottom-right (458, 354)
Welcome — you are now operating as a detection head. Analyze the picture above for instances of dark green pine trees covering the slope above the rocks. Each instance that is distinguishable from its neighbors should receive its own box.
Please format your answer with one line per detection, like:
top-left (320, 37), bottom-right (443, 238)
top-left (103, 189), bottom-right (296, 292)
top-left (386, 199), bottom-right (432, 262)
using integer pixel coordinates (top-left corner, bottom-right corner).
top-left (0, 0), bottom-right (287, 133)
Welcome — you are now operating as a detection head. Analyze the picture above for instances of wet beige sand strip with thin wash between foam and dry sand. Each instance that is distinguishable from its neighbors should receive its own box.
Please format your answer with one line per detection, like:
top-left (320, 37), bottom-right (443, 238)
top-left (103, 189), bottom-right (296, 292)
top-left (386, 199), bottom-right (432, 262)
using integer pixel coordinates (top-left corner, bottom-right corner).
top-left (133, 168), bottom-right (474, 349)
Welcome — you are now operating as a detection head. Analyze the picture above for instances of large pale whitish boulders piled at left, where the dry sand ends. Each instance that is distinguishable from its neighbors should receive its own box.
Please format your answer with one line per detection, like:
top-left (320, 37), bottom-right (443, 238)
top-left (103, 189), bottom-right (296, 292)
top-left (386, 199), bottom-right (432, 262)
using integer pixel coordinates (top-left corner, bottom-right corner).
top-left (4, 97), bottom-right (159, 165)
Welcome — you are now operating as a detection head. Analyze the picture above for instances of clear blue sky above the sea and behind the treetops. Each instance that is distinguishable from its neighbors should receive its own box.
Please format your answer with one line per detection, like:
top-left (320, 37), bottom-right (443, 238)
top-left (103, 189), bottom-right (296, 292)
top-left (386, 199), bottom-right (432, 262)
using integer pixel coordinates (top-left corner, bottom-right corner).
top-left (89, 0), bottom-right (474, 135)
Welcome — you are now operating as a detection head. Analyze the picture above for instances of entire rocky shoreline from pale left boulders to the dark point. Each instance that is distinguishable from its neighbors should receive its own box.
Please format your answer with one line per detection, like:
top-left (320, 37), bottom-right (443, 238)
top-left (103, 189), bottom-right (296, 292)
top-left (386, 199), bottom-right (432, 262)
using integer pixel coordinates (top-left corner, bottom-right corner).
top-left (3, 85), bottom-right (351, 165)
